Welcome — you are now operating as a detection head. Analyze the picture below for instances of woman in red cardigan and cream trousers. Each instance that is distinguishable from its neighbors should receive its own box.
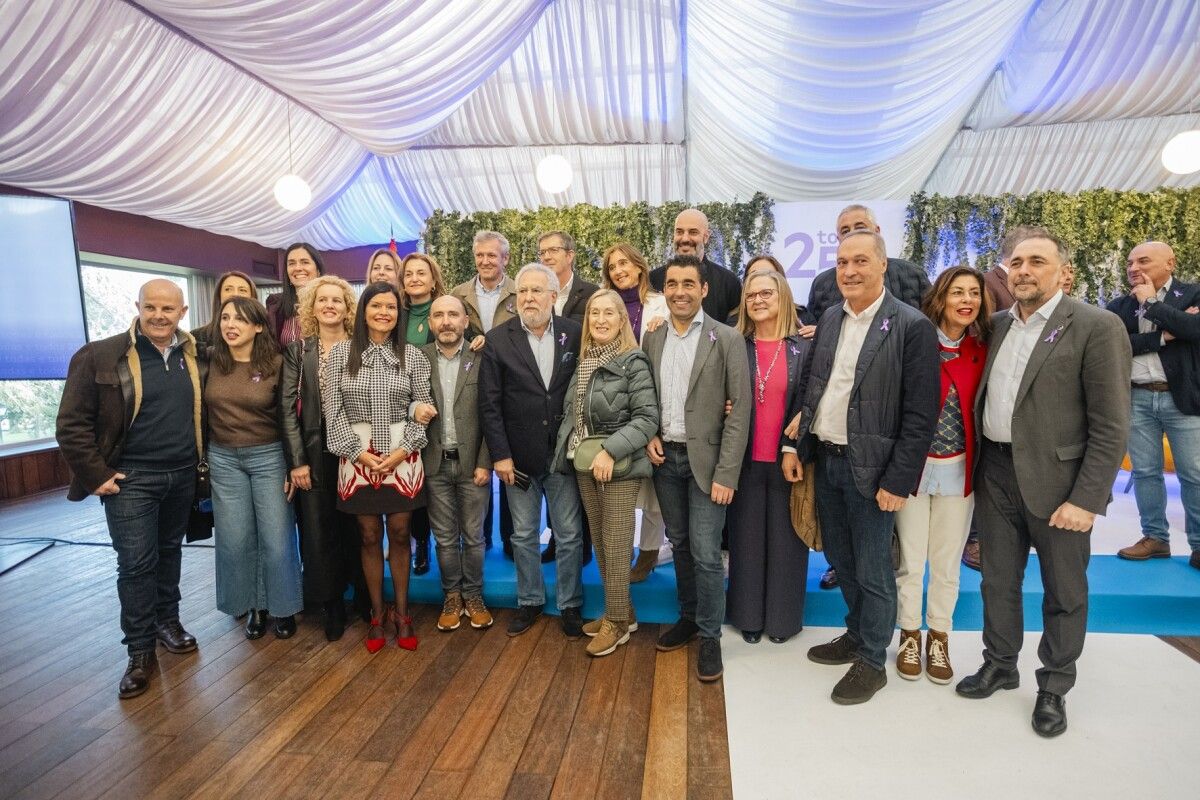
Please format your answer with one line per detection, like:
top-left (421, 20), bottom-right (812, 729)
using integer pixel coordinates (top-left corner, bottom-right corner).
top-left (896, 266), bottom-right (991, 684)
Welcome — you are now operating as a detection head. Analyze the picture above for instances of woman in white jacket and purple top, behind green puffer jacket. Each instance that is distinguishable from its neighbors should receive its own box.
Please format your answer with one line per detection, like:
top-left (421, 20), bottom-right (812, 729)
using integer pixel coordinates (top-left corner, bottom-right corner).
top-left (600, 242), bottom-right (668, 583)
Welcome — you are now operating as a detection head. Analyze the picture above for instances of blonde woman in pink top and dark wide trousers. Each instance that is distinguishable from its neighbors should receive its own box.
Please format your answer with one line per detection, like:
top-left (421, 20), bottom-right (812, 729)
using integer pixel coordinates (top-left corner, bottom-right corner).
top-left (726, 270), bottom-right (810, 644)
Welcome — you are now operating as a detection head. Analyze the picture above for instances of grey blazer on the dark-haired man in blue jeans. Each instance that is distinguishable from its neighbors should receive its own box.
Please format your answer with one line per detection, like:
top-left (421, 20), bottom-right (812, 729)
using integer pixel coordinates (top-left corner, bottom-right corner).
top-left (642, 314), bottom-right (751, 494)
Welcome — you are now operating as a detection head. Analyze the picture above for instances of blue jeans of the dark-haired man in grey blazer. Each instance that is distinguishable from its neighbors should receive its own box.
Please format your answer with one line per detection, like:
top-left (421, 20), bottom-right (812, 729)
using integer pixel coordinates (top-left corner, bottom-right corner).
top-left (654, 443), bottom-right (728, 639)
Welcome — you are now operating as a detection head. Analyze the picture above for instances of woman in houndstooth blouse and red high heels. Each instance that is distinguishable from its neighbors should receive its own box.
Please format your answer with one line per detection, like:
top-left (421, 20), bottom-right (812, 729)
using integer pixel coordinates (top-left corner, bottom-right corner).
top-left (323, 283), bottom-right (433, 652)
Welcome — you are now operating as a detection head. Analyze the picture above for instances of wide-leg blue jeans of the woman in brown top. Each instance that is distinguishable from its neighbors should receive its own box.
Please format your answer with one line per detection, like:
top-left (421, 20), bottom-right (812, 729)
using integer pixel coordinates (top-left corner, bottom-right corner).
top-left (209, 443), bottom-right (304, 616)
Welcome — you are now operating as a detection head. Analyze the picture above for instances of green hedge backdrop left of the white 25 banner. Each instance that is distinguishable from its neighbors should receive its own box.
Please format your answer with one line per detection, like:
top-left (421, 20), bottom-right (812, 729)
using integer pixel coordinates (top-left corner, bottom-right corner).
top-left (421, 193), bottom-right (775, 285)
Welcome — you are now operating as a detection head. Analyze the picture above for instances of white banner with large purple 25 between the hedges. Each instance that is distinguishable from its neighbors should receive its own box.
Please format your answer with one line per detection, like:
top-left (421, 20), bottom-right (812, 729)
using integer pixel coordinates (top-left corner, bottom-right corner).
top-left (770, 200), bottom-right (907, 305)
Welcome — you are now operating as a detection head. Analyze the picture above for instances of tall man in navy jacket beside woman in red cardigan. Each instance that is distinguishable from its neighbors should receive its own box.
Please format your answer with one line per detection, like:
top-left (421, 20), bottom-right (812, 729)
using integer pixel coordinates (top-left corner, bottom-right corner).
top-left (790, 230), bottom-right (941, 705)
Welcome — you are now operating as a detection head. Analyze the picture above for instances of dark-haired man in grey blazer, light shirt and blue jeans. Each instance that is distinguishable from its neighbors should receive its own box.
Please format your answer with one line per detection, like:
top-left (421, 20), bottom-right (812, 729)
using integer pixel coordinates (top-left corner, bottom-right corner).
top-left (642, 255), bottom-right (750, 681)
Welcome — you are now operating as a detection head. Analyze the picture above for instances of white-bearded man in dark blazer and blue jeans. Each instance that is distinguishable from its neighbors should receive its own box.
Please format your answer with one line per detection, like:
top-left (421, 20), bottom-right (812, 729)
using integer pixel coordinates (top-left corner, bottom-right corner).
top-left (479, 264), bottom-right (583, 639)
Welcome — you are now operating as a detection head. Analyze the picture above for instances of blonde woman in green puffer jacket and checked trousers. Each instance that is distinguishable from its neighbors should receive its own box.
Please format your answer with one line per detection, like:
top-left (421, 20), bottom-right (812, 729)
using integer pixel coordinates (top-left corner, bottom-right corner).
top-left (553, 289), bottom-right (659, 656)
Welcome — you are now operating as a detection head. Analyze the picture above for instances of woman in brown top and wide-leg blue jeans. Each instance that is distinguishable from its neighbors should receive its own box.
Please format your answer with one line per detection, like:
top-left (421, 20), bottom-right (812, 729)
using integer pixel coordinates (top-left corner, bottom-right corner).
top-left (204, 297), bottom-right (302, 639)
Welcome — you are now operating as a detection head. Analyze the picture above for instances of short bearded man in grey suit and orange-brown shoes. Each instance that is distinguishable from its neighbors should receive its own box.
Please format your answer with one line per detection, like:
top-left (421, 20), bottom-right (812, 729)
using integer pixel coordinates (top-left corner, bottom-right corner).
top-left (414, 295), bottom-right (492, 631)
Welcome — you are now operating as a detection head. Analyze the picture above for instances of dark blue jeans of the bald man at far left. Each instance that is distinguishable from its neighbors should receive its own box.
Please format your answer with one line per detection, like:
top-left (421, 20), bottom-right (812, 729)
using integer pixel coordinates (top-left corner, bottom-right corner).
top-left (100, 467), bottom-right (196, 654)
